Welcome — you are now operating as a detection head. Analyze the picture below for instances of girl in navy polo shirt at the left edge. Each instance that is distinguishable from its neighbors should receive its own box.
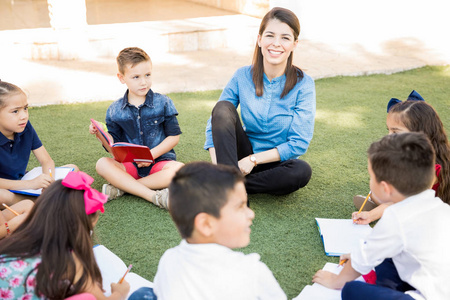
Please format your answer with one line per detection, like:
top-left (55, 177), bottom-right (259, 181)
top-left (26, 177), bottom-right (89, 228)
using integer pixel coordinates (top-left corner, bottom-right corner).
top-left (0, 81), bottom-right (78, 208)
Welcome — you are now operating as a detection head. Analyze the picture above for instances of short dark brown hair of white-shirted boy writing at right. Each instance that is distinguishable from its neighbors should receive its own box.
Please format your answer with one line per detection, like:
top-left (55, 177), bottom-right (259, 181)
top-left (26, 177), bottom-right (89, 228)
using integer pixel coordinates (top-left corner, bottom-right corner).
top-left (367, 132), bottom-right (435, 197)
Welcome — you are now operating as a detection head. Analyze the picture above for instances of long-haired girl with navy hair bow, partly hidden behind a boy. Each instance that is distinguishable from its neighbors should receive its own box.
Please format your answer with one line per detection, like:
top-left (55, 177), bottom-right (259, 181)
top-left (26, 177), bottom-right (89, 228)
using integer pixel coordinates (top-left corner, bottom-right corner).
top-left (352, 91), bottom-right (450, 224)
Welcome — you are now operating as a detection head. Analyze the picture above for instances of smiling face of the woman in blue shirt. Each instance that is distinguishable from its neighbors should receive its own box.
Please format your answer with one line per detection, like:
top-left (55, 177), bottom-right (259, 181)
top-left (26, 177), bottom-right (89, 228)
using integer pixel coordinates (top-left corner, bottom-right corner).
top-left (258, 19), bottom-right (298, 70)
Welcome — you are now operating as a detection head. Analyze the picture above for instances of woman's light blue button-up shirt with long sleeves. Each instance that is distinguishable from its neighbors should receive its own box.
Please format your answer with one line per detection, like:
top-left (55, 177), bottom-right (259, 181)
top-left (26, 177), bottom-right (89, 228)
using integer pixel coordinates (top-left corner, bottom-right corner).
top-left (204, 66), bottom-right (316, 161)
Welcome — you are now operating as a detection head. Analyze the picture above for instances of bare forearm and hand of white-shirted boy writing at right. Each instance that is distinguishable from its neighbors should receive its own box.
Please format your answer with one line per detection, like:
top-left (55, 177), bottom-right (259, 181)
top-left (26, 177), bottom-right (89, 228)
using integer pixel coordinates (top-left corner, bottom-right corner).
top-left (313, 259), bottom-right (361, 290)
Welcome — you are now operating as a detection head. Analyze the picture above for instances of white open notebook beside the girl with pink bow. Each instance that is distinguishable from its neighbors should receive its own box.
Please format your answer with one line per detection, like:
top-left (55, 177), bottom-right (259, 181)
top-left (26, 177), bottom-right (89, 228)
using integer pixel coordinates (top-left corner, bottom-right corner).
top-left (94, 245), bottom-right (153, 298)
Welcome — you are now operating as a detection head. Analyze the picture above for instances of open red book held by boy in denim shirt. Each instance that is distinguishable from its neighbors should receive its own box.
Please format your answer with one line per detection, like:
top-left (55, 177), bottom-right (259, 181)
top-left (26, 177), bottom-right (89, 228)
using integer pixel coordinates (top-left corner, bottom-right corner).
top-left (91, 119), bottom-right (154, 163)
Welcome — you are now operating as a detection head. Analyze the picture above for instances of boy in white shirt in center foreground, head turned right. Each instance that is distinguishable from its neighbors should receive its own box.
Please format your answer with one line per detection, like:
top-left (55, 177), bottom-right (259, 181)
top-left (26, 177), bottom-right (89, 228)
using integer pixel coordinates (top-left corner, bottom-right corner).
top-left (154, 162), bottom-right (286, 300)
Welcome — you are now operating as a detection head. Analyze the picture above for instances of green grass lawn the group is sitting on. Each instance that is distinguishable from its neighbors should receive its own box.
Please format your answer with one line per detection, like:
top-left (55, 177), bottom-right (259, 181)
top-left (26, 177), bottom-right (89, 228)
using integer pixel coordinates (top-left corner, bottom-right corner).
top-left (29, 66), bottom-right (450, 298)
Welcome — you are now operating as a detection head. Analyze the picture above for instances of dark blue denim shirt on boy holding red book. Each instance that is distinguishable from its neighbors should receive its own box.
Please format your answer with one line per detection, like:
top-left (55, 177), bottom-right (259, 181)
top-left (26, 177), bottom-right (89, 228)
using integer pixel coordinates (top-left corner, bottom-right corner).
top-left (106, 90), bottom-right (181, 169)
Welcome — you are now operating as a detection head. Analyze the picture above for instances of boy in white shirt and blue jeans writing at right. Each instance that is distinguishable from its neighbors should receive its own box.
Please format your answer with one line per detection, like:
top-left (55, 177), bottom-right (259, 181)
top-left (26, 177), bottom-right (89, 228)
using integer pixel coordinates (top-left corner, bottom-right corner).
top-left (313, 132), bottom-right (450, 300)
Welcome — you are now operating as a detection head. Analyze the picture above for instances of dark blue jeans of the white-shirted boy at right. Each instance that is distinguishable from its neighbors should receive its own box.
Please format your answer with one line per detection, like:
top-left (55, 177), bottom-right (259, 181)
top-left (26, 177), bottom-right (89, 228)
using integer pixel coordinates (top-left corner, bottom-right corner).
top-left (341, 258), bottom-right (414, 300)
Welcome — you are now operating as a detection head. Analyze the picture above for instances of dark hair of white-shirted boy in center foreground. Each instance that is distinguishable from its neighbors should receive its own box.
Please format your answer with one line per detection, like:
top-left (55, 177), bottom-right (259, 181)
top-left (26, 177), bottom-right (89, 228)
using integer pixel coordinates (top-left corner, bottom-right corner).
top-left (169, 162), bottom-right (244, 238)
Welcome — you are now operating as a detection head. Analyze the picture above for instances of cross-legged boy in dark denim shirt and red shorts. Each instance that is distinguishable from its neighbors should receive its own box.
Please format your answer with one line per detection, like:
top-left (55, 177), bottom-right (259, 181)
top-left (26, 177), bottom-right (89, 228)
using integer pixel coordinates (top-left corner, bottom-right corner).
top-left (89, 47), bottom-right (183, 209)
